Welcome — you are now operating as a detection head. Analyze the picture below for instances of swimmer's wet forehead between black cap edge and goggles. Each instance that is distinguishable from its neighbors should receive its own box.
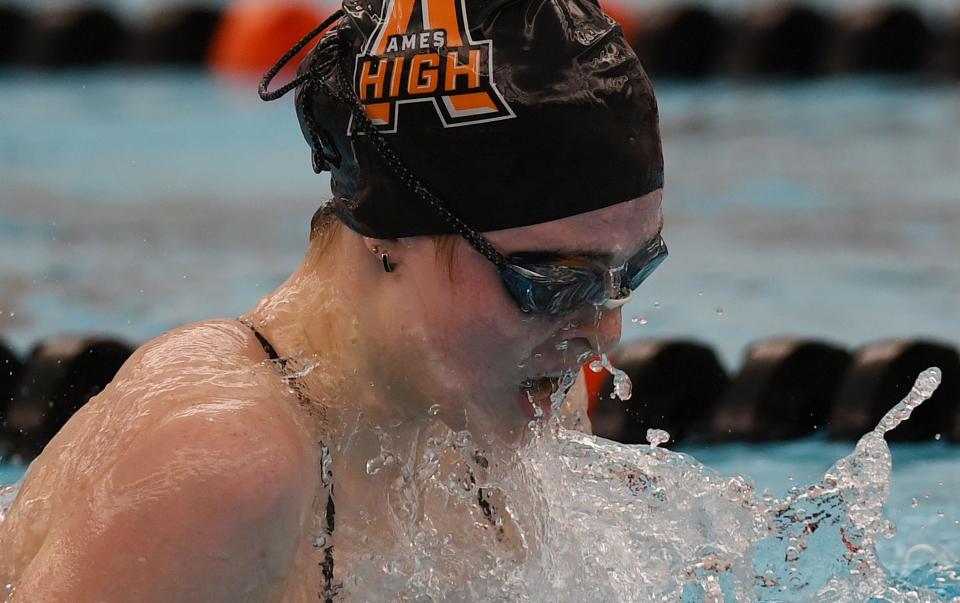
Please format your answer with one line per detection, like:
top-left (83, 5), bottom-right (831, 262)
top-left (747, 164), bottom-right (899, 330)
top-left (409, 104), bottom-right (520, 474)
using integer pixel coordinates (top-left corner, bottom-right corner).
top-left (486, 189), bottom-right (663, 259)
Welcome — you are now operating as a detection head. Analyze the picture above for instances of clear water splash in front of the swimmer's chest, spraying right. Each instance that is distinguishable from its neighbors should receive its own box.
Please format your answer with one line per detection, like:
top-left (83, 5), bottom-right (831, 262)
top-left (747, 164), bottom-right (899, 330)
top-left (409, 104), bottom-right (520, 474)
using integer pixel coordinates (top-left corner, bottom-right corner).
top-left (0, 372), bottom-right (960, 603)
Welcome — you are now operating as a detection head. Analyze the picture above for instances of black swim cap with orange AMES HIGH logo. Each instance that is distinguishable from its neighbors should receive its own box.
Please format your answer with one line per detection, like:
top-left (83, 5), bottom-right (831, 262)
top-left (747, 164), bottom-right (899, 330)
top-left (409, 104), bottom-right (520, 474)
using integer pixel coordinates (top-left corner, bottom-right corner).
top-left (282, 0), bottom-right (663, 238)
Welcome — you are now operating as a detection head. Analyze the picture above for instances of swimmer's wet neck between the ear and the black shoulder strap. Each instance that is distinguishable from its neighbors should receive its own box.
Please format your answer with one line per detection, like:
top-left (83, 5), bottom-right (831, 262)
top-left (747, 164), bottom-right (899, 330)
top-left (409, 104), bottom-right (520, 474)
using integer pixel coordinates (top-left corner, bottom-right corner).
top-left (243, 236), bottom-right (440, 458)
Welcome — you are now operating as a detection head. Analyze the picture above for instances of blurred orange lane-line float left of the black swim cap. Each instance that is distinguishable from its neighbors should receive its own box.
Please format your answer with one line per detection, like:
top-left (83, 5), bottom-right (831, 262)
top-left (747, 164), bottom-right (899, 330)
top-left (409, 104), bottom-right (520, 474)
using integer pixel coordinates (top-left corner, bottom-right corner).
top-left (208, 0), bottom-right (332, 75)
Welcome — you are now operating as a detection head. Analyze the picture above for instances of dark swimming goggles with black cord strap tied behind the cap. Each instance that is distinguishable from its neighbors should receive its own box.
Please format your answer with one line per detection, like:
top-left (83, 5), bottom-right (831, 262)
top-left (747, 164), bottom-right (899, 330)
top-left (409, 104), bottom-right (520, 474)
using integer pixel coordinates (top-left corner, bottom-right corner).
top-left (259, 9), bottom-right (667, 317)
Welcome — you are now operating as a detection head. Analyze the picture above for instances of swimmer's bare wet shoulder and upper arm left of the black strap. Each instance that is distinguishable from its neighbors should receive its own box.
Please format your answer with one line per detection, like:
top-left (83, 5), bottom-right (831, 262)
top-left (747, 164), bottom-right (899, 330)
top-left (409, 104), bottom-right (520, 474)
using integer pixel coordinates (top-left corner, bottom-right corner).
top-left (4, 321), bottom-right (317, 601)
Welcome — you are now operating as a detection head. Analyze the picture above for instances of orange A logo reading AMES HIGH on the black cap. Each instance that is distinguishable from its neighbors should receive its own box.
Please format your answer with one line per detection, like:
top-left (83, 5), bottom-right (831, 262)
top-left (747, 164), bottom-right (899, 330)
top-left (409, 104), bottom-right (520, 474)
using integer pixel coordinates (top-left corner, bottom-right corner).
top-left (348, 0), bottom-right (514, 132)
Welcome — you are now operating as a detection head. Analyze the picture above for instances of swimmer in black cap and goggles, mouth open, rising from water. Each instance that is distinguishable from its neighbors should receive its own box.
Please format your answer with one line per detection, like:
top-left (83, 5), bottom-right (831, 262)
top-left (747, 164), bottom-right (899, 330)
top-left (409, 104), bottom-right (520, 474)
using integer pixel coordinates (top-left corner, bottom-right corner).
top-left (0, 0), bottom-right (667, 603)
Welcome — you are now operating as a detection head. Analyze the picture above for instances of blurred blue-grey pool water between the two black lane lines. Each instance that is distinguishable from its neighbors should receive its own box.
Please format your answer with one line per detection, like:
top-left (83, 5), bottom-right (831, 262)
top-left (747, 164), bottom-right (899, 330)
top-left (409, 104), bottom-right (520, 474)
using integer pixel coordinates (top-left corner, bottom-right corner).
top-left (0, 71), bottom-right (960, 367)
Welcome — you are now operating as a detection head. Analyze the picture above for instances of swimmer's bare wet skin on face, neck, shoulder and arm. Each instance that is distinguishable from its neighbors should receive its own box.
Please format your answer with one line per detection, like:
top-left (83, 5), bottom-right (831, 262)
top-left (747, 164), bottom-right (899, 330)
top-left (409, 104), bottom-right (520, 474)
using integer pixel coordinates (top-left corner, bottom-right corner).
top-left (0, 191), bottom-right (662, 602)
